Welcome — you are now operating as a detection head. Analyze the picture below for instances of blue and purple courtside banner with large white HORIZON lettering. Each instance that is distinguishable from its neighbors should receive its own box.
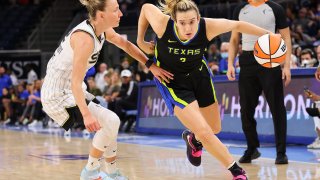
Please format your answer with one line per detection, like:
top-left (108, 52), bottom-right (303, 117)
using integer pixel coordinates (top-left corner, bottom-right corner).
top-left (137, 72), bottom-right (320, 143)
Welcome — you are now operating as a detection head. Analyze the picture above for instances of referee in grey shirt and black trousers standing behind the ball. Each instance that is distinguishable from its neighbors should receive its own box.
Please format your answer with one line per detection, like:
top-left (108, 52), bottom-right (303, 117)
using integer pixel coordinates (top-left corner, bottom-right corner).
top-left (227, 0), bottom-right (291, 164)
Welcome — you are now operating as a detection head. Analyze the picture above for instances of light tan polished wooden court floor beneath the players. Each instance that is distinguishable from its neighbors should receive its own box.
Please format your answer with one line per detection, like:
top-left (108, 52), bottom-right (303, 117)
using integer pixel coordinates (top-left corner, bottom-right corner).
top-left (0, 129), bottom-right (320, 180)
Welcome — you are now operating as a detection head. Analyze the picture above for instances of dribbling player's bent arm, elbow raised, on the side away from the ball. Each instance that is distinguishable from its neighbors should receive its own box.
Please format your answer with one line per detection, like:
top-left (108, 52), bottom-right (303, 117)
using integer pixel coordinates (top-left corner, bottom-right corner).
top-left (137, 4), bottom-right (170, 54)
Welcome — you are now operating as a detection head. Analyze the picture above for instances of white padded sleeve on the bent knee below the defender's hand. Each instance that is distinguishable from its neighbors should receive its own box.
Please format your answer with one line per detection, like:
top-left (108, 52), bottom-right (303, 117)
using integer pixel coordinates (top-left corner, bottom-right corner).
top-left (88, 102), bottom-right (120, 152)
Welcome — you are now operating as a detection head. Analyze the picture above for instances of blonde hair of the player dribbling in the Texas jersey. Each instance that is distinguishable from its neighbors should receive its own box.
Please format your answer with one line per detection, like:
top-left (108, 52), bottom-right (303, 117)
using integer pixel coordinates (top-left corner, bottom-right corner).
top-left (159, 0), bottom-right (200, 21)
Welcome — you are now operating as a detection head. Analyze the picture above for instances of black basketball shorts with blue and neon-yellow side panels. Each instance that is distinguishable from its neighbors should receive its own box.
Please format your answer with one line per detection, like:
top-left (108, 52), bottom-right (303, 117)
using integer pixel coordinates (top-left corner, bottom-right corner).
top-left (155, 60), bottom-right (217, 113)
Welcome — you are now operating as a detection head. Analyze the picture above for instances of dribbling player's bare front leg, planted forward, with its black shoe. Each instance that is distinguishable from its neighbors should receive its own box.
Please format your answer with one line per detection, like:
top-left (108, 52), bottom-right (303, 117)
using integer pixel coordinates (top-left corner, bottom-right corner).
top-left (174, 101), bottom-right (246, 179)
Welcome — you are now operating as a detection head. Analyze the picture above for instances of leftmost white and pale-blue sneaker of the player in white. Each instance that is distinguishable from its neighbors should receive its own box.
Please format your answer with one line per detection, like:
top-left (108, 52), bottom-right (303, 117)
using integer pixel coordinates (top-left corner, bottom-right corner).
top-left (80, 166), bottom-right (113, 180)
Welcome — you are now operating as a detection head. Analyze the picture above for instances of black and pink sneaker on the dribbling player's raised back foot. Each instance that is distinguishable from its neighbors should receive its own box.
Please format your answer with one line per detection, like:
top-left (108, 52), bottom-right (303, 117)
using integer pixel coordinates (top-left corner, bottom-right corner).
top-left (182, 129), bottom-right (203, 166)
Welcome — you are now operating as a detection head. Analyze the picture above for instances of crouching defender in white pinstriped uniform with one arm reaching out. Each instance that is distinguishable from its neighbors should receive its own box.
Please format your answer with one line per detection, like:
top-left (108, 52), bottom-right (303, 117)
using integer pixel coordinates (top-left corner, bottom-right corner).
top-left (41, 0), bottom-right (173, 180)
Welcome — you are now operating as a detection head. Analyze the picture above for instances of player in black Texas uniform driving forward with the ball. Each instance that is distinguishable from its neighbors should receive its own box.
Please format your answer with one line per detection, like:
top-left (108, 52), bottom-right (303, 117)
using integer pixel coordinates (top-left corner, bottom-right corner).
top-left (137, 0), bottom-right (268, 179)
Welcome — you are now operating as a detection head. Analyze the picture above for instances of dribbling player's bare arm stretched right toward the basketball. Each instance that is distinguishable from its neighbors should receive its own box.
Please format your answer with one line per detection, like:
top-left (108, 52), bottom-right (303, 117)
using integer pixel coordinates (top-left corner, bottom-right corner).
top-left (205, 18), bottom-right (270, 40)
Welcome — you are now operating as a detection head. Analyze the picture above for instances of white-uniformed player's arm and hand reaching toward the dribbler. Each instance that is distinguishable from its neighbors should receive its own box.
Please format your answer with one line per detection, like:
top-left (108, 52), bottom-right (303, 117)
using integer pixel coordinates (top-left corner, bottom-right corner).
top-left (106, 28), bottom-right (173, 83)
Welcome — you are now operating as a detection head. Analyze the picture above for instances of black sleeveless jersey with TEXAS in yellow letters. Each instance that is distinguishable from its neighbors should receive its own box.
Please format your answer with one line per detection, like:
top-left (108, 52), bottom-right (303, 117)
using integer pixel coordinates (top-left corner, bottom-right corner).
top-left (155, 18), bottom-right (209, 73)
